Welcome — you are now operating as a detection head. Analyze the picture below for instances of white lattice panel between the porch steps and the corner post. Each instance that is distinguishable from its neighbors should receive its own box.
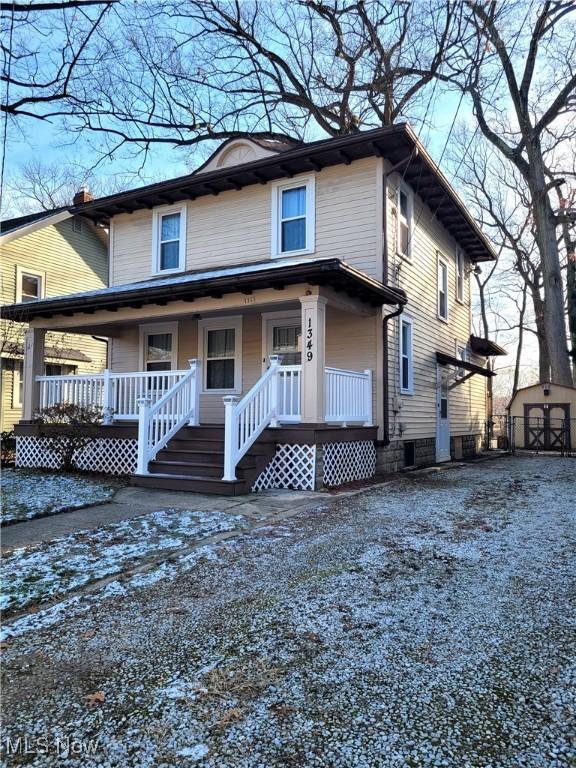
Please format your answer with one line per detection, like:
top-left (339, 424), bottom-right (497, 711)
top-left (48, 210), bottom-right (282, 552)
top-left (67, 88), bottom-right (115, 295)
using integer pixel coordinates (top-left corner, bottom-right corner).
top-left (252, 444), bottom-right (316, 491)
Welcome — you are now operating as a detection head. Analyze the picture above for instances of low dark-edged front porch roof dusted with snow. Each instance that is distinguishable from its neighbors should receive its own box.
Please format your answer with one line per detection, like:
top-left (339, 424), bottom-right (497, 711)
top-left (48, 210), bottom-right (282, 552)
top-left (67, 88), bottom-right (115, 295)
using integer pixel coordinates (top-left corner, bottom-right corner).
top-left (1, 258), bottom-right (407, 322)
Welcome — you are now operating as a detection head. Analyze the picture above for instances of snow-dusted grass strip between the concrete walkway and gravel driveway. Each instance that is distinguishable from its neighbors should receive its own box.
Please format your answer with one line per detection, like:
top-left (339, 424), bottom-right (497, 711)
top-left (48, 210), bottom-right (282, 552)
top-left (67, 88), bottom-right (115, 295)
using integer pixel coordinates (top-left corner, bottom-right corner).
top-left (0, 509), bottom-right (243, 612)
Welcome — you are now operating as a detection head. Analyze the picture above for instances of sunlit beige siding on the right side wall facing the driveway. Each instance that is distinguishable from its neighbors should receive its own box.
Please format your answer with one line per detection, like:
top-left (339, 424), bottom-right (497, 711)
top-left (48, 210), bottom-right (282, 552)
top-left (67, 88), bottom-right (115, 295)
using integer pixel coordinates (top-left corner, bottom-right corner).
top-left (388, 174), bottom-right (486, 440)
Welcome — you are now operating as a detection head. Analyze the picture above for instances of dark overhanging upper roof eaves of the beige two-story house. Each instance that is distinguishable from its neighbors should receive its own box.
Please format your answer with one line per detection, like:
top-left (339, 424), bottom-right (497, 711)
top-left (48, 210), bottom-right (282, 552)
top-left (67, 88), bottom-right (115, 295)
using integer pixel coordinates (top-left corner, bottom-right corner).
top-left (74, 123), bottom-right (496, 262)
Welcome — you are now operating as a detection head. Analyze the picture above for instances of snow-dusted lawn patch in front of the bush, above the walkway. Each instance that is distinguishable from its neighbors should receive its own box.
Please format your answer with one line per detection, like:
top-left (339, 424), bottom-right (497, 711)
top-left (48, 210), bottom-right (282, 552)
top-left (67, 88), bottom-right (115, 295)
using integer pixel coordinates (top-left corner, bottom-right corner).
top-left (0, 469), bottom-right (118, 525)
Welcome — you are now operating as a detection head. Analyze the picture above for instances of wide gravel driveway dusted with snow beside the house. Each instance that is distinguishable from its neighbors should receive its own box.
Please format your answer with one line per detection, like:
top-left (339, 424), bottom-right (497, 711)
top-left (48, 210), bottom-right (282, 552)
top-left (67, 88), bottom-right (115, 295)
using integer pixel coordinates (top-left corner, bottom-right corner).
top-left (3, 457), bottom-right (576, 768)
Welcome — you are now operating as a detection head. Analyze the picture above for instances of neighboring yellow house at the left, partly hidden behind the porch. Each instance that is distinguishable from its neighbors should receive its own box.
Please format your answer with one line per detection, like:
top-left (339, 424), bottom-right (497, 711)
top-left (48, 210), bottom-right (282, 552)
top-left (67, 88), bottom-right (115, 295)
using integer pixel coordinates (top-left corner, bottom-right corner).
top-left (0, 204), bottom-right (108, 431)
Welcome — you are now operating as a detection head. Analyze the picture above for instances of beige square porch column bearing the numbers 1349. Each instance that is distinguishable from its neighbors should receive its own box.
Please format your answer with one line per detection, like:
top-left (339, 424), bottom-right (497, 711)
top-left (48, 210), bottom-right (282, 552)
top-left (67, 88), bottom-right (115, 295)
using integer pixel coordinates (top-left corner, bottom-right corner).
top-left (300, 296), bottom-right (327, 424)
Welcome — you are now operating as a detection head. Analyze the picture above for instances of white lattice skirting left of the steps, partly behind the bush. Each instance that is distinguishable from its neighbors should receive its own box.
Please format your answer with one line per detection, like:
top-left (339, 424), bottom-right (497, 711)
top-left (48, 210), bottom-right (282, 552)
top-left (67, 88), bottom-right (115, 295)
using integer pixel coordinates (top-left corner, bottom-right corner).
top-left (16, 436), bottom-right (138, 475)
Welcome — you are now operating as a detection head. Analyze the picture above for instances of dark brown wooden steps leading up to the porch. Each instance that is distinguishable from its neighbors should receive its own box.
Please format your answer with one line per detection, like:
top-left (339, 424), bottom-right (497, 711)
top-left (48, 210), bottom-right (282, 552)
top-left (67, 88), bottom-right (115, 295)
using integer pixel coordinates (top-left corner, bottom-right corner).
top-left (131, 425), bottom-right (274, 496)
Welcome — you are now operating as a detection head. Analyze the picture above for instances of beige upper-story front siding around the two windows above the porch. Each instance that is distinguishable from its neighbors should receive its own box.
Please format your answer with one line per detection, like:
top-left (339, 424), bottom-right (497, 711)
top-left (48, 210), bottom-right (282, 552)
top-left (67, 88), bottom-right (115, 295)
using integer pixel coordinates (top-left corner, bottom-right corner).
top-left (112, 158), bottom-right (381, 285)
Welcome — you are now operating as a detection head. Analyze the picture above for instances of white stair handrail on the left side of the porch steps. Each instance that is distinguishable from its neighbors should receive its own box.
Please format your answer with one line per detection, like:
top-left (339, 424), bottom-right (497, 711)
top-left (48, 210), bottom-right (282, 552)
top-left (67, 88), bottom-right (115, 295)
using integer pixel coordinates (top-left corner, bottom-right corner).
top-left (137, 359), bottom-right (200, 475)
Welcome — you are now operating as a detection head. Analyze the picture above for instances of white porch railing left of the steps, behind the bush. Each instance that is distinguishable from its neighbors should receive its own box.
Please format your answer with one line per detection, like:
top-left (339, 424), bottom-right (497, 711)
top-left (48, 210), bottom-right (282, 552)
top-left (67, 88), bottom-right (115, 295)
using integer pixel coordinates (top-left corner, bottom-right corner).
top-left (36, 370), bottom-right (189, 423)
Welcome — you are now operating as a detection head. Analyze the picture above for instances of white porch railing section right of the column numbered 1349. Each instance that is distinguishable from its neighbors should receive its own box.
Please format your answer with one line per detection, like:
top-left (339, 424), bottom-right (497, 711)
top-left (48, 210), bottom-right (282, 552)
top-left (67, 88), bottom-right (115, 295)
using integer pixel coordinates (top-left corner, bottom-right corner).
top-left (325, 368), bottom-right (372, 427)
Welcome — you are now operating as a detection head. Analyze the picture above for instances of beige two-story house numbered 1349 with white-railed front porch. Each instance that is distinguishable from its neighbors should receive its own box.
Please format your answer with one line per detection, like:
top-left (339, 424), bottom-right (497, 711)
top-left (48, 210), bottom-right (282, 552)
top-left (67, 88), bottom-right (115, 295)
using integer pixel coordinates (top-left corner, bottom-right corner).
top-left (4, 125), bottom-right (502, 493)
